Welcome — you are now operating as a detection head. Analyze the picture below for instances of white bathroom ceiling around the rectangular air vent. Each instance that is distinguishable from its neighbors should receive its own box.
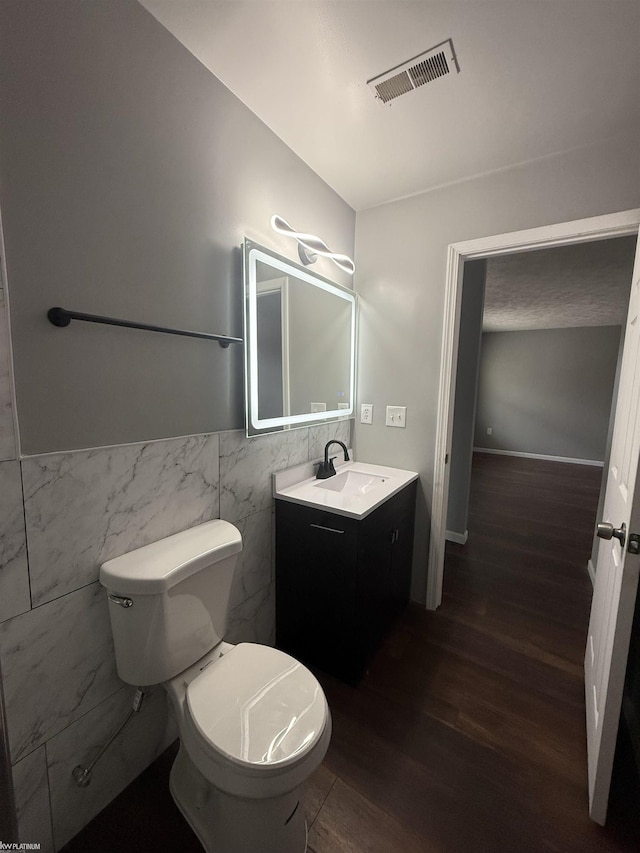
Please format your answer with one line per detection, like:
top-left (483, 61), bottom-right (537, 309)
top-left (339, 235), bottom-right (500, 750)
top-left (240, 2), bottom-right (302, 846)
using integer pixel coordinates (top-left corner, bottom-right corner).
top-left (141, 0), bottom-right (640, 210)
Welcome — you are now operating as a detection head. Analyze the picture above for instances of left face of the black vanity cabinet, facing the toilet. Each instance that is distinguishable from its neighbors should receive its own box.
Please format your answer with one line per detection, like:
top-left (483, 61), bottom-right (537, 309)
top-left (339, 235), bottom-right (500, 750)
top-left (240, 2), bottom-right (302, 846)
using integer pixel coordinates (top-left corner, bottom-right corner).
top-left (276, 501), bottom-right (358, 678)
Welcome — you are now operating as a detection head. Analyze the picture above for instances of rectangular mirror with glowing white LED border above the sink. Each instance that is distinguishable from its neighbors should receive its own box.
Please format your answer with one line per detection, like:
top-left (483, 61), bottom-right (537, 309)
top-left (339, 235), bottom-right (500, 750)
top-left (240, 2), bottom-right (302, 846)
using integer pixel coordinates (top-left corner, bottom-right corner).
top-left (244, 239), bottom-right (356, 435)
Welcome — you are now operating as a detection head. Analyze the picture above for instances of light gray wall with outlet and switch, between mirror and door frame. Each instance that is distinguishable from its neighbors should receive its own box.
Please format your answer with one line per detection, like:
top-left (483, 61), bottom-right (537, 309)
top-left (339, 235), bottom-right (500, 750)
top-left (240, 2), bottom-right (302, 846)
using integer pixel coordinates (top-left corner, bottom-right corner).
top-left (355, 138), bottom-right (640, 601)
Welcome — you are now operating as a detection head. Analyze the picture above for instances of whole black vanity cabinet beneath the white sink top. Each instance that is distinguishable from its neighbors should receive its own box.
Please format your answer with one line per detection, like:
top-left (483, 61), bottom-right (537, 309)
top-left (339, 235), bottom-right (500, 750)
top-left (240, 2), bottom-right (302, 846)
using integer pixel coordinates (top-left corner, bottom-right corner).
top-left (276, 481), bottom-right (416, 684)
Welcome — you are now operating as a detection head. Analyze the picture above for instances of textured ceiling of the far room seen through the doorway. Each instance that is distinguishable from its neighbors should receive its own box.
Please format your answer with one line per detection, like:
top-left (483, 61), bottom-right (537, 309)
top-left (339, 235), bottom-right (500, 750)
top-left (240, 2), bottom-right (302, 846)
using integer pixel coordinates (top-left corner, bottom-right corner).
top-left (483, 236), bottom-right (636, 332)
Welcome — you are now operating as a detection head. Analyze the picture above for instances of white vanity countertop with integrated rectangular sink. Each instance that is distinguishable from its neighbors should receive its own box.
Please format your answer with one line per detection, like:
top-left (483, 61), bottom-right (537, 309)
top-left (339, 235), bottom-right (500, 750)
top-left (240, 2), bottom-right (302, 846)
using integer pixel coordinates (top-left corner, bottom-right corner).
top-left (273, 459), bottom-right (418, 518)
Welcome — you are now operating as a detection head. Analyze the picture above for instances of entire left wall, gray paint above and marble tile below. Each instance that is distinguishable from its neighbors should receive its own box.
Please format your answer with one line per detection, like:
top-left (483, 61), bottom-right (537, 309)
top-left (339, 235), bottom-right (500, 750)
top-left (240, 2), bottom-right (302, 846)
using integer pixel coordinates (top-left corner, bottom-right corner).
top-left (0, 0), bottom-right (355, 853)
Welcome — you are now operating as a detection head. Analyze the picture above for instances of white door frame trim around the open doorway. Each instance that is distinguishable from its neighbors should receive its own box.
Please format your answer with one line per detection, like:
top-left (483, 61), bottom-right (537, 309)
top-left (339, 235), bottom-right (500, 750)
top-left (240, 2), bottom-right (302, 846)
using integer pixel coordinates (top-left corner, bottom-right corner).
top-left (426, 208), bottom-right (640, 610)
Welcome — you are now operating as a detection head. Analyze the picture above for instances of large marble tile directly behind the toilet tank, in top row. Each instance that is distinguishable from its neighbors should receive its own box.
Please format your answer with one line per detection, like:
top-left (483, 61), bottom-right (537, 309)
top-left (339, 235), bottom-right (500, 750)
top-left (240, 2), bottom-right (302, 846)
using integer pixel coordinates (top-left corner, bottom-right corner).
top-left (22, 434), bottom-right (219, 607)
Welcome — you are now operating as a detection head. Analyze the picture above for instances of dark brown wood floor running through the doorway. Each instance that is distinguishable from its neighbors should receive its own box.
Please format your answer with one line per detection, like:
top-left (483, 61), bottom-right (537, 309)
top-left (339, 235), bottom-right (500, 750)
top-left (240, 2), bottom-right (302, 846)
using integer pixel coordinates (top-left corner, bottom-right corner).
top-left (65, 455), bottom-right (640, 853)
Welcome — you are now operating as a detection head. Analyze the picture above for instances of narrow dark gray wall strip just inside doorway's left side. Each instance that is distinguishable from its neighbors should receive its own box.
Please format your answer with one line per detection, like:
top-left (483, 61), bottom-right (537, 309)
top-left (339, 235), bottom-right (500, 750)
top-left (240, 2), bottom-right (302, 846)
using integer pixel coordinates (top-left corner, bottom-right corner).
top-left (447, 260), bottom-right (487, 536)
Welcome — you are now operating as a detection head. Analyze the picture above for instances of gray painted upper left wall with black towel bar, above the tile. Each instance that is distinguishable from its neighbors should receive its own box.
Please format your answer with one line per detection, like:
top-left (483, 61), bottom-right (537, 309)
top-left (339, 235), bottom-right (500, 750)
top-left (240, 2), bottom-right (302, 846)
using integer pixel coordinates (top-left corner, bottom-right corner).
top-left (0, 0), bottom-right (355, 453)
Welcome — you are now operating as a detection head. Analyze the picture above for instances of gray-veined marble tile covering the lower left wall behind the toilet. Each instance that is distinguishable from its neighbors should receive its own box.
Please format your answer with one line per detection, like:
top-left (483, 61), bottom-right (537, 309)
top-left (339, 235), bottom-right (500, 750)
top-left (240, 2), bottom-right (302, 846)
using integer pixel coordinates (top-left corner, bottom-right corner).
top-left (0, 421), bottom-right (351, 851)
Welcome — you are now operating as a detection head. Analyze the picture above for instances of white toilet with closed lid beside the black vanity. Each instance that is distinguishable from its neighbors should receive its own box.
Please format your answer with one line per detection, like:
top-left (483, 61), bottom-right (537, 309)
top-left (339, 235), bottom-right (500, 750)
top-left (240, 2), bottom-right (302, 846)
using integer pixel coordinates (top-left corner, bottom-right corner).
top-left (100, 520), bottom-right (331, 853)
